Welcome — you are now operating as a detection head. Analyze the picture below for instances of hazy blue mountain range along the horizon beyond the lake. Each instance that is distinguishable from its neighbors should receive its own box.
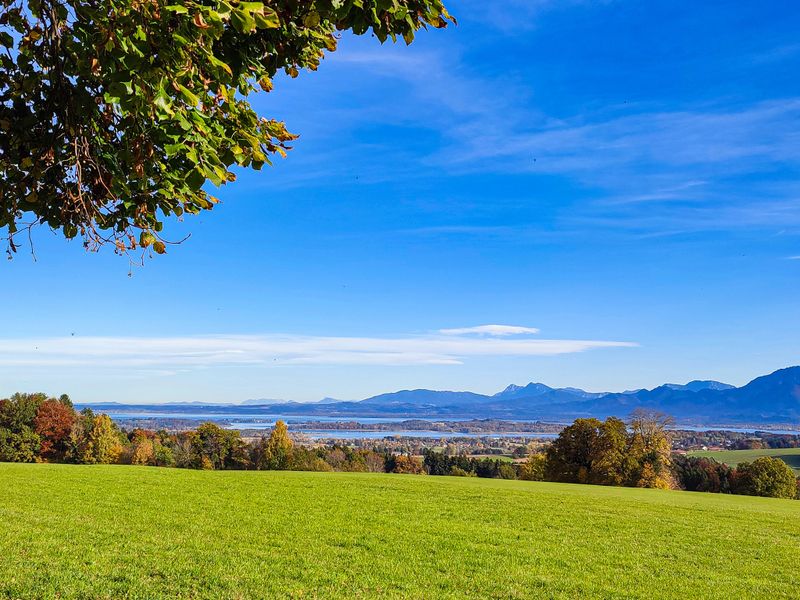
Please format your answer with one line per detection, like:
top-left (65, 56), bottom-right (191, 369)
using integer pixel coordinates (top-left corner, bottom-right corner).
top-left (81, 367), bottom-right (800, 425)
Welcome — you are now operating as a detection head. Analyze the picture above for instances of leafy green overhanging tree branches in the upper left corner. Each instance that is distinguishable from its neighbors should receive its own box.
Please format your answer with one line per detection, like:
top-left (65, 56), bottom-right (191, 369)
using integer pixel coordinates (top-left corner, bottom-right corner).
top-left (0, 0), bottom-right (453, 253)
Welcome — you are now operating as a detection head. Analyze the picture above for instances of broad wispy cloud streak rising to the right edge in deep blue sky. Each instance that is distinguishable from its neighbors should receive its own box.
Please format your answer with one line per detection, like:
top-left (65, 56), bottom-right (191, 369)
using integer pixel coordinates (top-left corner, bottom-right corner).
top-left (444, 98), bottom-right (800, 179)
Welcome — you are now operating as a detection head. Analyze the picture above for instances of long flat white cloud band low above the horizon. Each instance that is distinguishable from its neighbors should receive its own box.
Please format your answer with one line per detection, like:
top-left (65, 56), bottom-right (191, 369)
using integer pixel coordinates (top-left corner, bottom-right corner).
top-left (0, 325), bottom-right (637, 373)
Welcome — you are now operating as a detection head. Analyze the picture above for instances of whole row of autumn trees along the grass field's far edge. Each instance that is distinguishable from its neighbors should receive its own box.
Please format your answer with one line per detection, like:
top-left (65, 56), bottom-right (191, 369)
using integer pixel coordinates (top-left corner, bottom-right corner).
top-left (0, 394), bottom-right (800, 498)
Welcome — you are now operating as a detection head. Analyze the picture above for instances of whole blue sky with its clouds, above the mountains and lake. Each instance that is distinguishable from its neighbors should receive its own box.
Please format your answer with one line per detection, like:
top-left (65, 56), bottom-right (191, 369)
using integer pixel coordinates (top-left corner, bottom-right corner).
top-left (0, 0), bottom-right (800, 402)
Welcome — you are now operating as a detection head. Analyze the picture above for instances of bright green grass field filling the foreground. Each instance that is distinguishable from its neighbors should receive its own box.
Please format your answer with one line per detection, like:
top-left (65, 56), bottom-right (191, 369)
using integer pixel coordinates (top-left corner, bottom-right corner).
top-left (0, 464), bottom-right (800, 599)
